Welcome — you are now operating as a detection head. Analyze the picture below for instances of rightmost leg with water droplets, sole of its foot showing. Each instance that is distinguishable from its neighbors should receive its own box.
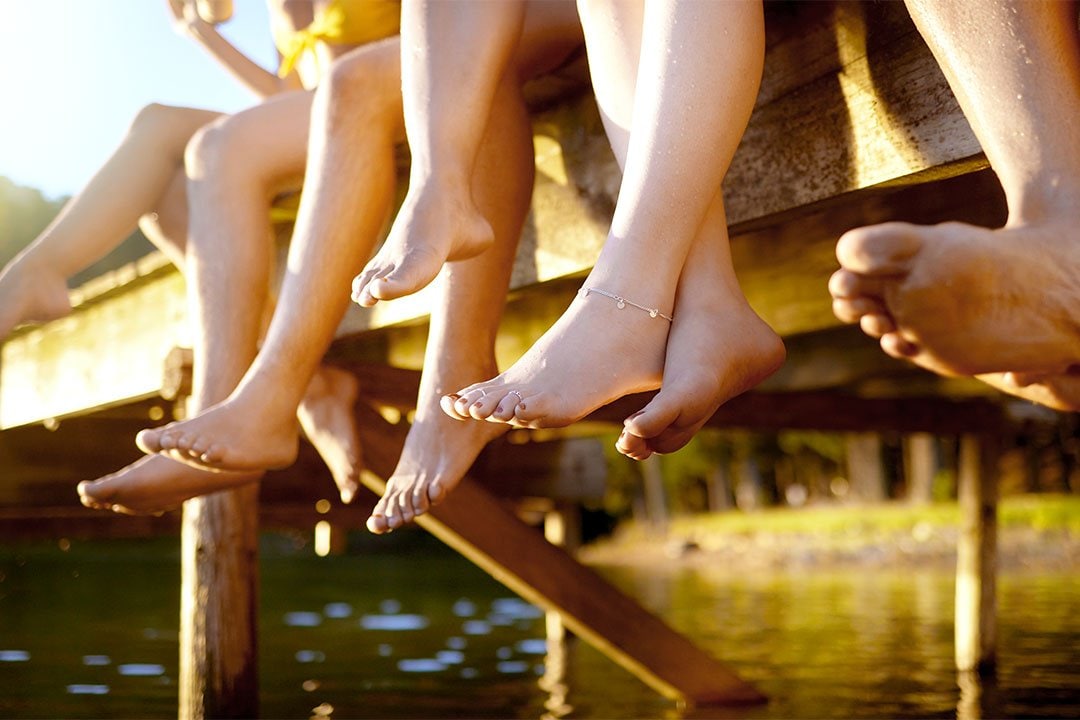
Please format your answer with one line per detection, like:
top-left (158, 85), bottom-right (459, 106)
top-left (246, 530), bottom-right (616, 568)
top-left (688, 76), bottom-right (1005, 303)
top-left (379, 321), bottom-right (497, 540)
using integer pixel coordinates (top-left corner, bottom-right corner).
top-left (829, 0), bottom-right (1080, 388)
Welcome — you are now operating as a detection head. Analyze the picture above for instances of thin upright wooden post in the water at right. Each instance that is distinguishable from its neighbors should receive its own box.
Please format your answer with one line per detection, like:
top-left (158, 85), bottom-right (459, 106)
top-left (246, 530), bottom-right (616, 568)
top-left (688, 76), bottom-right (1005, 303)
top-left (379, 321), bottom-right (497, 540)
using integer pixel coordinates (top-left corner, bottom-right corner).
top-left (956, 435), bottom-right (998, 673)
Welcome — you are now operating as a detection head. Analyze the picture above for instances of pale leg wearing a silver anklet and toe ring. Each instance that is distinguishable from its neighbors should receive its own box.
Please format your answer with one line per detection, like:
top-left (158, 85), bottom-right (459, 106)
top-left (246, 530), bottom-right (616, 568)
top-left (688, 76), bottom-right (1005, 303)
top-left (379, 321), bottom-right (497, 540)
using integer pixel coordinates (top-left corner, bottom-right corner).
top-left (447, 2), bottom-right (777, 426)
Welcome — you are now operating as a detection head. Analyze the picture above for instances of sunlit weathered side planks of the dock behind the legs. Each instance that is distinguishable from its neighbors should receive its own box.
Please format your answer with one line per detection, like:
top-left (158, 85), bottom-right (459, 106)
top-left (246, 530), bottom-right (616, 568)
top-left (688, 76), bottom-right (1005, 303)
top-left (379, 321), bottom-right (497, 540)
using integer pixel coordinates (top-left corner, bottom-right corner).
top-left (0, 2), bottom-right (1001, 427)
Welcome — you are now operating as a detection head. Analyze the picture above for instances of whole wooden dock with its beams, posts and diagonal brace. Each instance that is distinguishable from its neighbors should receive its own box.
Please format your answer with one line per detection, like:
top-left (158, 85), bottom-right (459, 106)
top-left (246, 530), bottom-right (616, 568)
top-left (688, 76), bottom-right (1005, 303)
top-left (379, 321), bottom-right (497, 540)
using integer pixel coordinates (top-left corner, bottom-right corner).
top-left (0, 2), bottom-right (1045, 718)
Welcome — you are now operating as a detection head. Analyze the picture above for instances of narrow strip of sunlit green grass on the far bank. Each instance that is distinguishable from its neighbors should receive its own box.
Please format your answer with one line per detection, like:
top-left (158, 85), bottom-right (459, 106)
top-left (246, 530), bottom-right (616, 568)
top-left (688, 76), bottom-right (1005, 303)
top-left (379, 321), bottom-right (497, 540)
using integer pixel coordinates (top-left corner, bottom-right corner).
top-left (671, 494), bottom-right (1080, 535)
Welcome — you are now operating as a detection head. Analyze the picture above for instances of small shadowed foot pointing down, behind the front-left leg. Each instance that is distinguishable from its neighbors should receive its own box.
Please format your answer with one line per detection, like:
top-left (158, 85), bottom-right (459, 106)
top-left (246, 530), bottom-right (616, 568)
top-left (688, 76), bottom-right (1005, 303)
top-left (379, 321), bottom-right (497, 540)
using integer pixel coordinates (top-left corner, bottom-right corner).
top-left (296, 365), bottom-right (364, 503)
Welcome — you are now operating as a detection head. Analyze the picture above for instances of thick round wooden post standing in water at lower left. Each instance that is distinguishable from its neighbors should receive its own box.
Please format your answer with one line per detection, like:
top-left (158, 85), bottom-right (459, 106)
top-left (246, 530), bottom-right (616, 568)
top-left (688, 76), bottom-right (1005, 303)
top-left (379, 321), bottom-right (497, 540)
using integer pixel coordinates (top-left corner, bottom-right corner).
top-left (179, 484), bottom-right (259, 720)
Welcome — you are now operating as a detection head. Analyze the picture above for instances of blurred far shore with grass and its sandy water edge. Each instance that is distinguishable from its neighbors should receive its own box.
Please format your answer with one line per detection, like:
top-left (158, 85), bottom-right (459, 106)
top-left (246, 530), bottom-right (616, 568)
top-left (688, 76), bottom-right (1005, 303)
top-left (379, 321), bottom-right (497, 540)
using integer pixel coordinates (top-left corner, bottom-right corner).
top-left (582, 494), bottom-right (1080, 570)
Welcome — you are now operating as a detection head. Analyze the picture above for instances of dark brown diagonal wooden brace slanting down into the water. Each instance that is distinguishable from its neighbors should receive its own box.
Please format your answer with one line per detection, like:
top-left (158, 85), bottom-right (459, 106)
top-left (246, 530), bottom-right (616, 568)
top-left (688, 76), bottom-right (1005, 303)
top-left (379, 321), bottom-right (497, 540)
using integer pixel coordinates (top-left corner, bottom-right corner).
top-left (357, 403), bottom-right (765, 704)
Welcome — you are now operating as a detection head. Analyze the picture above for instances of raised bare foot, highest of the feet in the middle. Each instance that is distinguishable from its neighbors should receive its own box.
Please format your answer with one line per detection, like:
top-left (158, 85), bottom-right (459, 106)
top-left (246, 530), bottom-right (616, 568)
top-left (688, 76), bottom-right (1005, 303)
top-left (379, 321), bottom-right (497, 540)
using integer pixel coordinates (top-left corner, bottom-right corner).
top-left (352, 188), bottom-right (495, 308)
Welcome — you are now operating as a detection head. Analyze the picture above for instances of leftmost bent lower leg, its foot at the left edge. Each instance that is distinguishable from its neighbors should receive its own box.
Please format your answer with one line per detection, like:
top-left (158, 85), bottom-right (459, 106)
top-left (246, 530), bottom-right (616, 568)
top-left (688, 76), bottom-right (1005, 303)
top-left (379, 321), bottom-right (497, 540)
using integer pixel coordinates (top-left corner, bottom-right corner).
top-left (0, 105), bottom-right (218, 340)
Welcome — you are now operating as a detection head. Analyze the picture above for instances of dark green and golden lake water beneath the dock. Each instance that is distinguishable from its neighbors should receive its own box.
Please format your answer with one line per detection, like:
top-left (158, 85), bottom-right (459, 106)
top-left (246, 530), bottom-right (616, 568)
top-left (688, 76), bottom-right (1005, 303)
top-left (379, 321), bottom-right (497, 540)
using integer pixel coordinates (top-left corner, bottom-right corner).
top-left (0, 532), bottom-right (1080, 718)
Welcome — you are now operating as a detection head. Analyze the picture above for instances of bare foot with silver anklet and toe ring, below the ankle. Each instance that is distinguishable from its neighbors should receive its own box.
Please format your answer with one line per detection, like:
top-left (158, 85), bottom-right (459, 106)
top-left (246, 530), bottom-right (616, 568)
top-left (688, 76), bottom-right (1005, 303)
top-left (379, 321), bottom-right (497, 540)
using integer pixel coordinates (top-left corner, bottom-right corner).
top-left (443, 281), bottom-right (672, 427)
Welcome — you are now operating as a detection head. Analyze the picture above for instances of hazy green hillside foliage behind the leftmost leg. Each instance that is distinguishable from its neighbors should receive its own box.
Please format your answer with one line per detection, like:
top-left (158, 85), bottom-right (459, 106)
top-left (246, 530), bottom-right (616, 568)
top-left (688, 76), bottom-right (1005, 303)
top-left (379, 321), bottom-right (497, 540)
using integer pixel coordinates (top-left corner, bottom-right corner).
top-left (0, 177), bottom-right (153, 287)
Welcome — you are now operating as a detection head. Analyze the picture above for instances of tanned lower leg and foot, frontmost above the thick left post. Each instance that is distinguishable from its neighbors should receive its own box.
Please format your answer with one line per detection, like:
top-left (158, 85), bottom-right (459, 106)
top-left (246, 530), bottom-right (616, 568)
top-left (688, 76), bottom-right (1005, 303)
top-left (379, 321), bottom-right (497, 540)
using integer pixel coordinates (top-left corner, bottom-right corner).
top-left (137, 38), bottom-right (401, 471)
